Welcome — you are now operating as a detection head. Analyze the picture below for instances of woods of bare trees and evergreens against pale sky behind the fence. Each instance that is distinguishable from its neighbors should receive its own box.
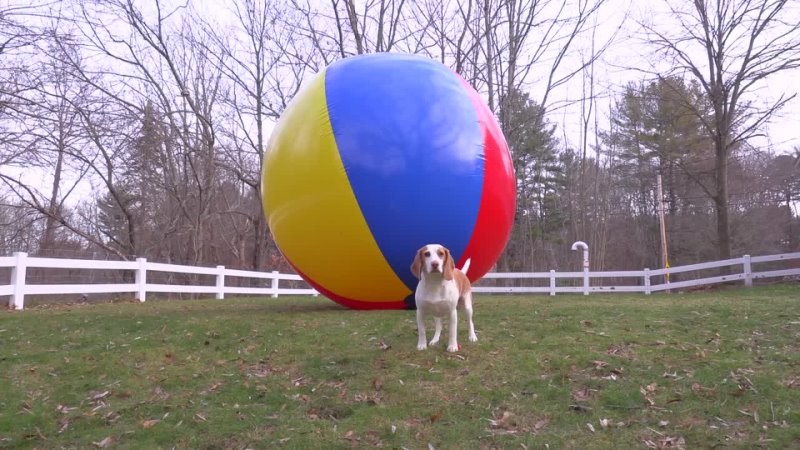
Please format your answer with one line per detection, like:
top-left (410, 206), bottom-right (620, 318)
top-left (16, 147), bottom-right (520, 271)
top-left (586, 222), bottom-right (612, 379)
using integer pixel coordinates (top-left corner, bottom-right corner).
top-left (0, 0), bottom-right (800, 271)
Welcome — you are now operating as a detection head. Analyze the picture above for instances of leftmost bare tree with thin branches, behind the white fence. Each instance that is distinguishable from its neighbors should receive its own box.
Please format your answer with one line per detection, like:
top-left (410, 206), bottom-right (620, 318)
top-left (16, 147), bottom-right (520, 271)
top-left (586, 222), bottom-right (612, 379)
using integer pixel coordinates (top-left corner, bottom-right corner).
top-left (0, 15), bottom-right (109, 253)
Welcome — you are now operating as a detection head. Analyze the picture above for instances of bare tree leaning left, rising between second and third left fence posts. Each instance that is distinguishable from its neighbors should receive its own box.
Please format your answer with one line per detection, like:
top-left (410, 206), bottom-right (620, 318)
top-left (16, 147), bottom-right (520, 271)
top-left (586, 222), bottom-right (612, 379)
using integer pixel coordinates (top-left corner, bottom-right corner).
top-left (64, 0), bottom-right (227, 263)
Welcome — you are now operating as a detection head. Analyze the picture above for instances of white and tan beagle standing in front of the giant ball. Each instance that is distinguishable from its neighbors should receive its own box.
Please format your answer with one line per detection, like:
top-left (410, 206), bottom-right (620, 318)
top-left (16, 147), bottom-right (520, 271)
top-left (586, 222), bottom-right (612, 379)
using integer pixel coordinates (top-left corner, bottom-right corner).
top-left (411, 244), bottom-right (478, 352)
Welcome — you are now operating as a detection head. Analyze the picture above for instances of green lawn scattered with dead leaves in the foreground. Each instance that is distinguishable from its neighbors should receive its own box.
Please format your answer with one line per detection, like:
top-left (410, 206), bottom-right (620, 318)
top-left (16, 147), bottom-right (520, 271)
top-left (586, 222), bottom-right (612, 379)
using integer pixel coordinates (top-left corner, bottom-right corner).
top-left (0, 285), bottom-right (800, 449)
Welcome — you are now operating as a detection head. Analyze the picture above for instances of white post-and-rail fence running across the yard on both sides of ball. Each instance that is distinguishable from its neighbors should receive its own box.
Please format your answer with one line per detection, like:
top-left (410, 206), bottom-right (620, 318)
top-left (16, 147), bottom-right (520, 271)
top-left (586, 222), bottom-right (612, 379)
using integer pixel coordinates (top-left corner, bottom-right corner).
top-left (0, 252), bottom-right (800, 309)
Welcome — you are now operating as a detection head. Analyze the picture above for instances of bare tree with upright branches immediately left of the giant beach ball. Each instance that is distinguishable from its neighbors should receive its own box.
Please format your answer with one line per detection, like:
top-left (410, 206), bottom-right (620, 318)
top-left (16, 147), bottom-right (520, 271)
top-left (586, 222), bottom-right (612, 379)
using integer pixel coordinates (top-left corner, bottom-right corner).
top-left (200, 0), bottom-right (306, 269)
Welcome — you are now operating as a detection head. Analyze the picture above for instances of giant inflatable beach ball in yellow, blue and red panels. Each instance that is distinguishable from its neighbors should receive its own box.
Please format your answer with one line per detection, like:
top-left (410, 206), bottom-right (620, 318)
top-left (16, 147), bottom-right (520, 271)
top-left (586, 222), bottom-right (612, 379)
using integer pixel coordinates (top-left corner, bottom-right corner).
top-left (261, 53), bottom-right (516, 309)
